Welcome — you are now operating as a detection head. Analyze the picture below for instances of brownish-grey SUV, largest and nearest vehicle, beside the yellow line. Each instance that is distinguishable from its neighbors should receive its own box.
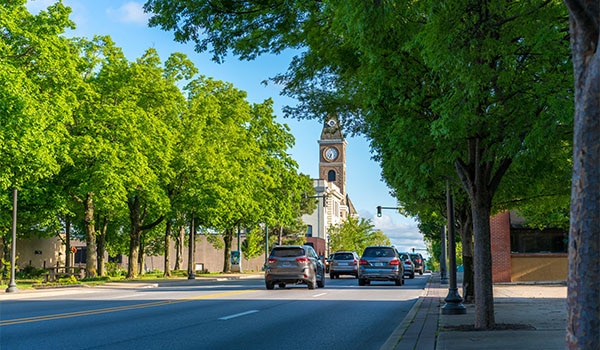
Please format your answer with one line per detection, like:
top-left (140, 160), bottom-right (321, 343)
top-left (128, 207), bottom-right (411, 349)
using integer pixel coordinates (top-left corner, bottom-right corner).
top-left (265, 245), bottom-right (325, 289)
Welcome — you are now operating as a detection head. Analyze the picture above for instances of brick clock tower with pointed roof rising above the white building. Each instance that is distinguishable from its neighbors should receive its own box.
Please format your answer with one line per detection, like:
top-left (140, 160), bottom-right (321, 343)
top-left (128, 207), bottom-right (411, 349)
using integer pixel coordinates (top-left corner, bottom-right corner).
top-left (319, 118), bottom-right (347, 196)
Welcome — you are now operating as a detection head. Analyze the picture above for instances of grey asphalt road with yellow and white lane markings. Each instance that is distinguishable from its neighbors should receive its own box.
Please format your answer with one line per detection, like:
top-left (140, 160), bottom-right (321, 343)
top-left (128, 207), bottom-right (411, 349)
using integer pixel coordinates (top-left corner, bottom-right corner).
top-left (0, 275), bottom-right (429, 350)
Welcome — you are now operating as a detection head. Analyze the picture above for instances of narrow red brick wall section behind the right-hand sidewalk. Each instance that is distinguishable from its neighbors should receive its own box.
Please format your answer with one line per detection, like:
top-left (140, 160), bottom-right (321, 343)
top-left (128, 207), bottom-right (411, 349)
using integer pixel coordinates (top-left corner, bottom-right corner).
top-left (490, 211), bottom-right (511, 282)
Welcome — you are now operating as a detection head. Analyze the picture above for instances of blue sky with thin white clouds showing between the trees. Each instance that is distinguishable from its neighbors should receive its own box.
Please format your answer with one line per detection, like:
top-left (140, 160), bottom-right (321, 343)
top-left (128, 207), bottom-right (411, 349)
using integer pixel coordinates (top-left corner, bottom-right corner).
top-left (28, 0), bottom-right (426, 255)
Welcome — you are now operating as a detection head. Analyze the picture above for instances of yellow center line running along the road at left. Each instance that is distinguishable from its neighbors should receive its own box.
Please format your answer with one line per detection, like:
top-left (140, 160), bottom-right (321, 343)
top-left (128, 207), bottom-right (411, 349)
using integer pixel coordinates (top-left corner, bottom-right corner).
top-left (0, 289), bottom-right (257, 327)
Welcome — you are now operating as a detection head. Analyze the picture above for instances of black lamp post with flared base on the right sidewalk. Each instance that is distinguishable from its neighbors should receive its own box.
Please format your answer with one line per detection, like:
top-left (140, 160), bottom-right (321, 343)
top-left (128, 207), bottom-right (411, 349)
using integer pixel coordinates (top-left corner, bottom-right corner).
top-left (442, 181), bottom-right (467, 315)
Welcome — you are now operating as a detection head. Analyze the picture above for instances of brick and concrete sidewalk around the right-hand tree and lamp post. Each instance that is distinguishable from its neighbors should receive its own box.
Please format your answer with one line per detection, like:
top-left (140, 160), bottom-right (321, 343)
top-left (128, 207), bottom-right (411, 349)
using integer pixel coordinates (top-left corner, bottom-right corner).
top-left (381, 273), bottom-right (567, 350)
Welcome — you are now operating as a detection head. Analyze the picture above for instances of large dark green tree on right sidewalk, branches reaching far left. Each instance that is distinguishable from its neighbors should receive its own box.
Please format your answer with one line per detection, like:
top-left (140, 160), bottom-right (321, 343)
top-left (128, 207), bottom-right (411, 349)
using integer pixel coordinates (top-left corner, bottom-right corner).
top-left (146, 0), bottom-right (571, 329)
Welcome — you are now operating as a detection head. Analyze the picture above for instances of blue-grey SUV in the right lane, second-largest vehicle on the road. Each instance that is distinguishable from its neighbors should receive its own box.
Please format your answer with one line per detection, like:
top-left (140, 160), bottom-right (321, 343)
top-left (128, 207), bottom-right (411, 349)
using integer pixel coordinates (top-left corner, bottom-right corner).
top-left (358, 246), bottom-right (404, 286)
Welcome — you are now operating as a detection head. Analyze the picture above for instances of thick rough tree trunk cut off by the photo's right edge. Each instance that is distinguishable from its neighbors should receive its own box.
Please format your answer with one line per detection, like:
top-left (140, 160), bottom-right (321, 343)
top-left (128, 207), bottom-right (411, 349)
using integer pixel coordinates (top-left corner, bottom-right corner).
top-left (565, 0), bottom-right (600, 349)
